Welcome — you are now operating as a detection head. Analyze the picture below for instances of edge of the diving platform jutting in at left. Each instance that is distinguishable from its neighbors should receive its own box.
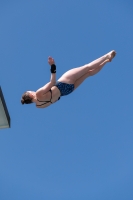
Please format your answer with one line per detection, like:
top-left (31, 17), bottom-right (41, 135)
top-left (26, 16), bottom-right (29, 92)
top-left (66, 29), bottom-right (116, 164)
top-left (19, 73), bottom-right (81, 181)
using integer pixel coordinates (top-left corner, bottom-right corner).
top-left (0, 87), bottom-right (10, 129)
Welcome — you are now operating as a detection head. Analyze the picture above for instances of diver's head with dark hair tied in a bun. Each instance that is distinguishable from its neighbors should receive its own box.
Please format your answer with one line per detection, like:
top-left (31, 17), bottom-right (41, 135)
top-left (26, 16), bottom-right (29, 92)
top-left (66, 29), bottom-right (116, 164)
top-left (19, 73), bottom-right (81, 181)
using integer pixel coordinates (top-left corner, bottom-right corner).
top-left (21, 91), bottom-right (35, 104)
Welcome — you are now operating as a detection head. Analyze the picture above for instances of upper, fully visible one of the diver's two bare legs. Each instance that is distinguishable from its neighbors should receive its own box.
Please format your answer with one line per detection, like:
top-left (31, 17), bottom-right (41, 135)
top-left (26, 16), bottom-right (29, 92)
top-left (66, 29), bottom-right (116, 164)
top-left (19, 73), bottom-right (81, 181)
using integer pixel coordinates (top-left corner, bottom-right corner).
top-left (58, 51), bottom-right (116, 84)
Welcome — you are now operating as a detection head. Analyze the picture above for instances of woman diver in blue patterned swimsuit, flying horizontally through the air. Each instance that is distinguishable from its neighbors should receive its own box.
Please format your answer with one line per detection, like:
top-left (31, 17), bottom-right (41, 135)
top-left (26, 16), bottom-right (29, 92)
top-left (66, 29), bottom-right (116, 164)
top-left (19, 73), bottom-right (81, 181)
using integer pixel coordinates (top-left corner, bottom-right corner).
top-left (21, 50), bottom-right (116, 108)
